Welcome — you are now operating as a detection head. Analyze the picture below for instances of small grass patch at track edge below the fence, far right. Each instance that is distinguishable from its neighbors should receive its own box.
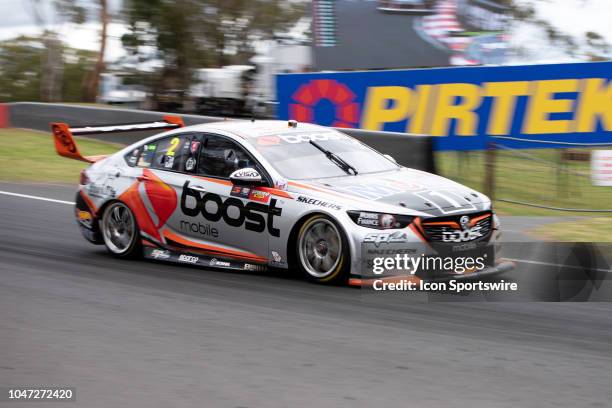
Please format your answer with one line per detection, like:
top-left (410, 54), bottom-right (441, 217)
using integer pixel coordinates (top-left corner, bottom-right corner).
top-left (529, 217), bottom-right (612, 242)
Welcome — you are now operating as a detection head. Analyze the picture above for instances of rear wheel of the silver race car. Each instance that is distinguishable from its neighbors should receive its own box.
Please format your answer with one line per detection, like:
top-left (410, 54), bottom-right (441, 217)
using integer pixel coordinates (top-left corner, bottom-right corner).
top-left (100, 201), bottom-right (142, 258)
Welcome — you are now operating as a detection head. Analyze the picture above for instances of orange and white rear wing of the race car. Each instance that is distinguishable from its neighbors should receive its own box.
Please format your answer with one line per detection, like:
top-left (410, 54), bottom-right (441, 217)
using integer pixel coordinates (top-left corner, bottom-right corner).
top-left (51, 115), bottom-right (185, 163)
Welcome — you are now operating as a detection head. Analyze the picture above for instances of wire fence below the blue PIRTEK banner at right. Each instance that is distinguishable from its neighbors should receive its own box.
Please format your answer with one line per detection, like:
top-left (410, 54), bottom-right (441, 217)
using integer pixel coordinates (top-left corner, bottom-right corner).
top-left (436, 144), bottom-right (612, 215)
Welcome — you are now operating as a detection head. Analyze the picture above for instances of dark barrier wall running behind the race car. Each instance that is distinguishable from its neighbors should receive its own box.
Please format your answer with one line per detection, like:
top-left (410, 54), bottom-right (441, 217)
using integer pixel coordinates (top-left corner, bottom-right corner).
top-left (5, 102), bottom-right (435, 173)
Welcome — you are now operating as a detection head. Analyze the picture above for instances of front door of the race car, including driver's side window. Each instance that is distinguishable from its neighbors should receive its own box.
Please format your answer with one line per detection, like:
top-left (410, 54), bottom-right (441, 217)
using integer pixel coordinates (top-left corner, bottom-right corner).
top-left (180, 134), bottom-right (274, 263)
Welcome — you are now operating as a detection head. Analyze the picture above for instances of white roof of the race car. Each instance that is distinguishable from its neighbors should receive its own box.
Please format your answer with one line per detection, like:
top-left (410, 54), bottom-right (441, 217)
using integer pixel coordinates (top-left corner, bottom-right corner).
top-left (181, 120), bottom-right (334, 139)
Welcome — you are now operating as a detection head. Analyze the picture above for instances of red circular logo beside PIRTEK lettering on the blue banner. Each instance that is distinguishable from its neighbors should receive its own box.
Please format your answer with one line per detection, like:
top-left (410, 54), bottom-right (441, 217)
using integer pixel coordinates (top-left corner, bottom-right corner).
top-left (289, 79), bottom-right (359, 128)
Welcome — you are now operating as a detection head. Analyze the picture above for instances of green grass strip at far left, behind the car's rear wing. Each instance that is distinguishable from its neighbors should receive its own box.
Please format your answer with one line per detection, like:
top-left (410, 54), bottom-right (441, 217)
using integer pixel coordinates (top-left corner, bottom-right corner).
top-left (0, 129), bottom-right (121, 183)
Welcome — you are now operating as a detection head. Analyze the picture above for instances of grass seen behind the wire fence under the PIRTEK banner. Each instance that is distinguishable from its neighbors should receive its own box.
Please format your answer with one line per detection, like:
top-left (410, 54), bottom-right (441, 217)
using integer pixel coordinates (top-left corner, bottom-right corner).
top-left (436, 149), bottom-right (612, 217)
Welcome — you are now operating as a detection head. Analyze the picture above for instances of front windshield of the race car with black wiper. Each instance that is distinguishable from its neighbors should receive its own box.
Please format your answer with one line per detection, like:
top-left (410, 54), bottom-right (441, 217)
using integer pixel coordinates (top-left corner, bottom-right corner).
top-left (254, 131), bottom-right (399, 180)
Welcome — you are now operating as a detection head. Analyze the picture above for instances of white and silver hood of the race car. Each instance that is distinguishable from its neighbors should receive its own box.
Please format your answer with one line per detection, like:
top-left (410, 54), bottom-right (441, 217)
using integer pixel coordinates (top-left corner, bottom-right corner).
top-left (310, 168), bottom-right (490, 216)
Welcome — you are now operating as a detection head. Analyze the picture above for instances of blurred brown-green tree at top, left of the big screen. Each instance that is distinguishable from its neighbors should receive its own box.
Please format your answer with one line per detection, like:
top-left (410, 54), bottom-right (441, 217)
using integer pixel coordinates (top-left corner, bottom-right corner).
top-left (122, 0), bottom-right (305, 102)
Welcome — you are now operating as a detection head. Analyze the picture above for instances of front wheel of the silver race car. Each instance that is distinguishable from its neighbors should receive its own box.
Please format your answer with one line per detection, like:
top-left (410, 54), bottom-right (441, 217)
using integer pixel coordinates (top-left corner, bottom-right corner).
top-left (295, 214), bottom-right (351, 285)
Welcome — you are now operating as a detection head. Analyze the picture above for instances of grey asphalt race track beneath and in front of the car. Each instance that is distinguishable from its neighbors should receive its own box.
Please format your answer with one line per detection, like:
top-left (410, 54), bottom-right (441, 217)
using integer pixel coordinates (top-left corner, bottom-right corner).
top-left (0, 184), bottom-right (612, 408)
